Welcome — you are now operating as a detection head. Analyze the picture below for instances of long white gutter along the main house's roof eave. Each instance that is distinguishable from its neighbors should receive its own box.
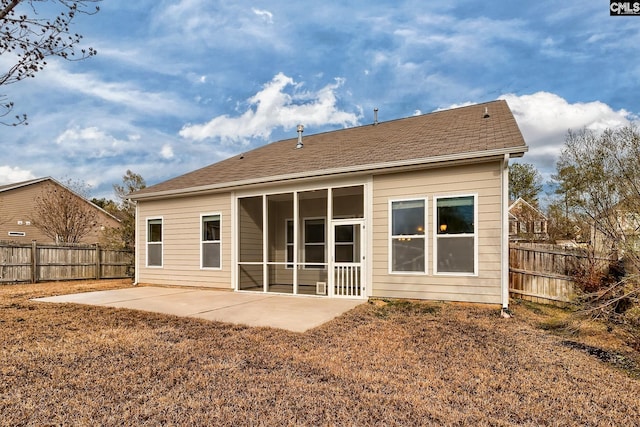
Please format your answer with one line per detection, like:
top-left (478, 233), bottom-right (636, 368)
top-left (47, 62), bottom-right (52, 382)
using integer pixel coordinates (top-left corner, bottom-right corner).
top-left (129, 146), bottom-right (528, 200)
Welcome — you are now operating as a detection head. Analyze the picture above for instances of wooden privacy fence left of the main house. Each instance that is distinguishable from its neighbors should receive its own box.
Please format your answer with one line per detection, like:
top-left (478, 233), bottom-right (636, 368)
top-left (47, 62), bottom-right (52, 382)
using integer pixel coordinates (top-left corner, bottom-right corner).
top-left (0, 242), bottom-right (133, 284)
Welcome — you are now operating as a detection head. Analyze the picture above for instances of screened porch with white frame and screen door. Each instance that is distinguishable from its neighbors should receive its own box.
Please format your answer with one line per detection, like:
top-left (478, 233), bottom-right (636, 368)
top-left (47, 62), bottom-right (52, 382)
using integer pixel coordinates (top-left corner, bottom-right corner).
top-left (235, 184), bottom-right (366, 298)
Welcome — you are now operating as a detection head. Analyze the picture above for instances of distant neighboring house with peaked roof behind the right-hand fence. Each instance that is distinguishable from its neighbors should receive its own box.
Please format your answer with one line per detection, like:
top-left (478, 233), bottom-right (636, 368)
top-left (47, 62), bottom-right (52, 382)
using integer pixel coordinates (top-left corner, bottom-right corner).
top-left (509, 197), bottom-right (549, 242)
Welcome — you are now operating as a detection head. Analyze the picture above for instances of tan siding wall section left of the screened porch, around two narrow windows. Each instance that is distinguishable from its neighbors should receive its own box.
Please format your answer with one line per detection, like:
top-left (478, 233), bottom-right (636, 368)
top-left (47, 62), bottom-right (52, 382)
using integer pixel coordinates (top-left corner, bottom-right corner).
top-left (137, 193), bottom-right (232, 289)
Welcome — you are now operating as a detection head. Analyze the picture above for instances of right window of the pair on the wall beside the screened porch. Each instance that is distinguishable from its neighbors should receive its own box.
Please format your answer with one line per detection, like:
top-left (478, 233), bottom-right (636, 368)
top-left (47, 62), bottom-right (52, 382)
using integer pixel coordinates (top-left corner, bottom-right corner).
top-left (435, 195), bottom-right (476, 274)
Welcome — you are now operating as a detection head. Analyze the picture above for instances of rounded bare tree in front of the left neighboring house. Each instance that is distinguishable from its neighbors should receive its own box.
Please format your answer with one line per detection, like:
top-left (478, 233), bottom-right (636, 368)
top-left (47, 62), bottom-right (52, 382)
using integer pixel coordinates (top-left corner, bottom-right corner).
top-left (31, 181), bottom-right (98, 243)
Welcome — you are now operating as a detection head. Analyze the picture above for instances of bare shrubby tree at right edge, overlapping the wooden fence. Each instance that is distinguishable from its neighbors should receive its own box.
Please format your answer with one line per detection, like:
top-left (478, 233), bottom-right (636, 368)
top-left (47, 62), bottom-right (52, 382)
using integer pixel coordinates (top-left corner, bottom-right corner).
top-left (556, 126), bottom-right (640, 346)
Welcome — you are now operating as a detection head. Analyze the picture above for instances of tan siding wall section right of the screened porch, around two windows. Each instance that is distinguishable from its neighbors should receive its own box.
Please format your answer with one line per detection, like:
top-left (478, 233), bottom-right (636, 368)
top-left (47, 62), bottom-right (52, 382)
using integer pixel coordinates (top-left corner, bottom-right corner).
top-left (371, 161), bottom-right (502, 304)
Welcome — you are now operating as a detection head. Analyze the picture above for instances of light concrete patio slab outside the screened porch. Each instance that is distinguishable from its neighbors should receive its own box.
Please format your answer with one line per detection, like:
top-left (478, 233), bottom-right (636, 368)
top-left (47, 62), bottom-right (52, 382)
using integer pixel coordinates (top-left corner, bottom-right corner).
top-left (34, 286), bottom-right (364, 332)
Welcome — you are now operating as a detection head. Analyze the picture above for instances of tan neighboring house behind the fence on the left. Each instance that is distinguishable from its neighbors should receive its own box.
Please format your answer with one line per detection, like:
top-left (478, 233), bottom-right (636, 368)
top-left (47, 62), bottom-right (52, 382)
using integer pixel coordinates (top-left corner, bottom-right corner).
top-left (0, 177), bottom-right (120, 244)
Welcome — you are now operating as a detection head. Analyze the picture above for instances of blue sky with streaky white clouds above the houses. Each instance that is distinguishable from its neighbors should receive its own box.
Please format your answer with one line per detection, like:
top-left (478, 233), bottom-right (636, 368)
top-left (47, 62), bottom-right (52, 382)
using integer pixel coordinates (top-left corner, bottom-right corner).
top-left (0, 0), bottom-right (640, 202)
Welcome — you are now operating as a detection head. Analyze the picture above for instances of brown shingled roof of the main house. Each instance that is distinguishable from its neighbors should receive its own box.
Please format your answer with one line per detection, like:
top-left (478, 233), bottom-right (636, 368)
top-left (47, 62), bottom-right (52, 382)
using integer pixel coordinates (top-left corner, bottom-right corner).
top-left (131, 100), bottom-right (527, 200)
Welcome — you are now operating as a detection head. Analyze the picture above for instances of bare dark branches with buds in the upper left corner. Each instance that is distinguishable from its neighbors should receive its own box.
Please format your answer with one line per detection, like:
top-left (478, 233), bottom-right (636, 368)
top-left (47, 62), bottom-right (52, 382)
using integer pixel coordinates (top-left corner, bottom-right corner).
top-left (0, 0), bottom-right (101, 126)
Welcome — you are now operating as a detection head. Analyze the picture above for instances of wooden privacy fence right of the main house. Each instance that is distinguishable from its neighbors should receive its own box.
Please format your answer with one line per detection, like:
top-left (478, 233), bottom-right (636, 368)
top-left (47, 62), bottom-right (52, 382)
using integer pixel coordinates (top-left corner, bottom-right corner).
top-left (509, 243), bottom-right (609, 305)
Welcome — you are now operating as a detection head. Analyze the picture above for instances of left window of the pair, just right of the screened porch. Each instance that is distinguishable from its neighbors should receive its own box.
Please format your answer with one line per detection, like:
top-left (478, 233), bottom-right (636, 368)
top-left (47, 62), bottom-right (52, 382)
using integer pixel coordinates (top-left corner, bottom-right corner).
top-left (390, 199), bottom-right (427, 273)
